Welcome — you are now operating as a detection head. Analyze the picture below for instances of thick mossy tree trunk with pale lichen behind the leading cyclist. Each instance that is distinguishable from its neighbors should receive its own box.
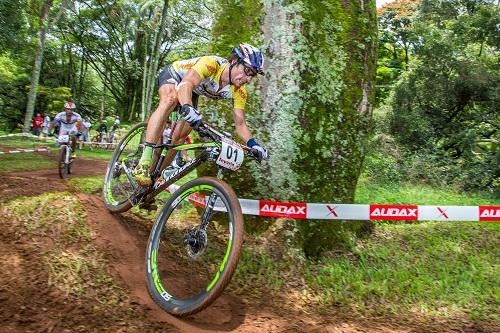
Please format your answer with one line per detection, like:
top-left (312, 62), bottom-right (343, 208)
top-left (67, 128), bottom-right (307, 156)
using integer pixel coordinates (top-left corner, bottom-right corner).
top-left (209, 0), bottom-right (377, 256)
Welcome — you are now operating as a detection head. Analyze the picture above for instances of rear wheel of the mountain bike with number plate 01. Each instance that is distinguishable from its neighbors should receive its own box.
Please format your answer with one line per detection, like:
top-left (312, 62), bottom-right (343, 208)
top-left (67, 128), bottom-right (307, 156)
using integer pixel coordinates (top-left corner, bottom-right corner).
top-left (103, 123), bottom-right (146, 213)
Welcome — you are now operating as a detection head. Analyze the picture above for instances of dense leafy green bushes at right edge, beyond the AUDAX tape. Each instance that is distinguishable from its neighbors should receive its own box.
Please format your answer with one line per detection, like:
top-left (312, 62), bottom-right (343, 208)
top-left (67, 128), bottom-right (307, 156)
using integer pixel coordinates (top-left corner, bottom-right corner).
top-left (391, 1), bottom-right (500, 192)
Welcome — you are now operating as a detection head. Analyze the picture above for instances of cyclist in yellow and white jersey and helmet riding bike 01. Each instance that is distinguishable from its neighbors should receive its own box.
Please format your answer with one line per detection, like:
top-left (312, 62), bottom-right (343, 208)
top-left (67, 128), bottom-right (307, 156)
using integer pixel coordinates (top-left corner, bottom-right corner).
top-left (134, 44), bottom-right (267, 186)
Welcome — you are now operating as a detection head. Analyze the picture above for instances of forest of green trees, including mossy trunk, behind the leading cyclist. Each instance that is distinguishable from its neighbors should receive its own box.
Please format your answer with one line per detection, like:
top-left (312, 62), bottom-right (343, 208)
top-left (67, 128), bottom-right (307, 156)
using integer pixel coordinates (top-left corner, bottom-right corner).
top-left (0, 0), bottom-right (500, 252)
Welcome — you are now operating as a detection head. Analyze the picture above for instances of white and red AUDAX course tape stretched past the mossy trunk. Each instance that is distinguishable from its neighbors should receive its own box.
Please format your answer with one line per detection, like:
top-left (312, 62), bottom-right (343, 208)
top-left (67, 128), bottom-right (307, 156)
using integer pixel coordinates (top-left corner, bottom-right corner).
top-left (167, 185), bottom-right (500, 222)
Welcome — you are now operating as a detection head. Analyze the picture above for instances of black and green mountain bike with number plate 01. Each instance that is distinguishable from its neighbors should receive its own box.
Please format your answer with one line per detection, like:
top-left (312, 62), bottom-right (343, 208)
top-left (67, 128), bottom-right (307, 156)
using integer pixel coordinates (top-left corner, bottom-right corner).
top-left (103, 120), bottom-right (256, 316)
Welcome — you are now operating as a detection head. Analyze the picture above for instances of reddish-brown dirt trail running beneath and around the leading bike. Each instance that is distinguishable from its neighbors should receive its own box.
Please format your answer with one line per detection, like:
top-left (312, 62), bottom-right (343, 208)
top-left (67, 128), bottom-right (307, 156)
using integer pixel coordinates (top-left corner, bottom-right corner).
top-left (0, 152), bottom-right (496, 333)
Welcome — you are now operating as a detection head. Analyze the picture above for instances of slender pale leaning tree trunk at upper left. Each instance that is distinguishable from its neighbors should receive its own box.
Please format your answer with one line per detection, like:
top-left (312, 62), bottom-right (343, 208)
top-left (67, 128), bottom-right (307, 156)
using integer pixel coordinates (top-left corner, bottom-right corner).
top-left (23, 0), bottom-right (52, 133)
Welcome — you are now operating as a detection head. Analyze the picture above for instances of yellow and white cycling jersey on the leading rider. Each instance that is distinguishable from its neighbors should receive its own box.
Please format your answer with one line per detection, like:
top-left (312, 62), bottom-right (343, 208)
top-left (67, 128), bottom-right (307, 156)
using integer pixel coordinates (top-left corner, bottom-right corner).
top-left (171, 56), bottom-right (247, 110)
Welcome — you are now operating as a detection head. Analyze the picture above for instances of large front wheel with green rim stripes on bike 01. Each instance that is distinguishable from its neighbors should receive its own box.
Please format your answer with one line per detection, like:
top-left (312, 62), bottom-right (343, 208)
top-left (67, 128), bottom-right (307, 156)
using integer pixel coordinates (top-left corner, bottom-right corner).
top-left (146, 177), bottom-right (243, 316)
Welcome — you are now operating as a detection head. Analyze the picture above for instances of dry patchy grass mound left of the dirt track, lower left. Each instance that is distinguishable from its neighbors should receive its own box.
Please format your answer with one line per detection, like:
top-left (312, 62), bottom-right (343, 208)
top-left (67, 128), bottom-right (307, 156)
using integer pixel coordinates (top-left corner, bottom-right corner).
top-left (0, 192), bottom-right (127, 307)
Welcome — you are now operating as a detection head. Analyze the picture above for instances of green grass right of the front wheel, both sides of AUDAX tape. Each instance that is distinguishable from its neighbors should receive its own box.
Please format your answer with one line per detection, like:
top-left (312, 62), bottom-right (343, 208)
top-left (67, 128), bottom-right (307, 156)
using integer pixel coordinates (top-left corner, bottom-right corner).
top-left (230, 179), bottom-right (500, 323)
